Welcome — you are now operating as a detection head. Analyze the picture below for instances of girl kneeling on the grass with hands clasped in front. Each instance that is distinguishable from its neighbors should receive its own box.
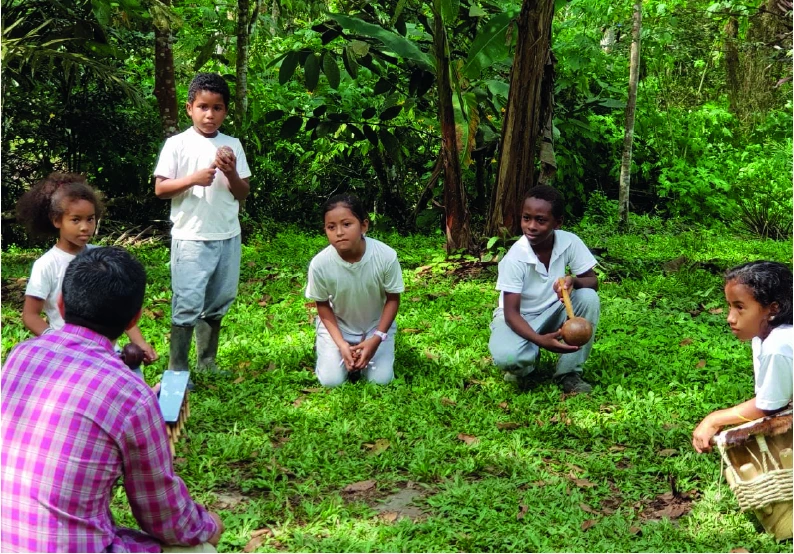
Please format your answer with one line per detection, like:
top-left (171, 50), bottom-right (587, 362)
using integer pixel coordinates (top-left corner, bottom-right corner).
top-left (306, 194), bottom-right (404, 387)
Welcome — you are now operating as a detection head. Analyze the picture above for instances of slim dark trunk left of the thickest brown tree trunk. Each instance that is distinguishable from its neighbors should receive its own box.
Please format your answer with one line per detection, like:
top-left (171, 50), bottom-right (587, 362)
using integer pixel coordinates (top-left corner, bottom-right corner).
top-left (433, 2), bottom-right (472, 254)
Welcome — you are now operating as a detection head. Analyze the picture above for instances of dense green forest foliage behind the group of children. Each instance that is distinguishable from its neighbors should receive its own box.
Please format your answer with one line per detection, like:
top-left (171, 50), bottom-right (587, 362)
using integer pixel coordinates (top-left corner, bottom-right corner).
top-left (2, 0), bottom-right (792, 246)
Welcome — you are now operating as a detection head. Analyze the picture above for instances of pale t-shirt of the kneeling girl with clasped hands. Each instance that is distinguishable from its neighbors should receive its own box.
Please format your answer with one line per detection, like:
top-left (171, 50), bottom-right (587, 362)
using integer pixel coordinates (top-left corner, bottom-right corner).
top-left (306, 238), bottom-right (405, 335)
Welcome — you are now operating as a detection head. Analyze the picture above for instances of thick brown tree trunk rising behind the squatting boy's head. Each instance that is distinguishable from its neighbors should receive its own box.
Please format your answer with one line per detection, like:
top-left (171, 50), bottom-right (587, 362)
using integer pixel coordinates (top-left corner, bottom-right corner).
top-left (487, 0), bottom-right (554, 236)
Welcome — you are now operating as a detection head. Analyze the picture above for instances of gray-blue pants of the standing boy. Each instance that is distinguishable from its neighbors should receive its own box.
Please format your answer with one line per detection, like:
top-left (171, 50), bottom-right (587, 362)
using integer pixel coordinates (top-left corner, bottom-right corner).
top-left (171, 235), bottom-right (241, 327)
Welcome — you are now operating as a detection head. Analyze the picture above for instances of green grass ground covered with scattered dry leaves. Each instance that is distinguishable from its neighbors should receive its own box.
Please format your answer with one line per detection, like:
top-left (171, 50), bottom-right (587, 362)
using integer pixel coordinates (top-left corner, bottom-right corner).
top-left (2, 222), bottom-right (791, 552)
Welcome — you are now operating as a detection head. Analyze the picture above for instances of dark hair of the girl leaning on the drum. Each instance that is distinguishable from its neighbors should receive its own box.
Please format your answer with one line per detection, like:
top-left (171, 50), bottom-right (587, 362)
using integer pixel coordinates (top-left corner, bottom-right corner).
top-left (725, 261), bottom-right (794, 327)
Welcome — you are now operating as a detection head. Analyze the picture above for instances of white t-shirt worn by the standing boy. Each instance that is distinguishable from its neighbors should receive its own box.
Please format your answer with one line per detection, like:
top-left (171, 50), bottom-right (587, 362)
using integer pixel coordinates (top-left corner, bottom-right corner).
top-left (154, 127), bottom-right (251, 240)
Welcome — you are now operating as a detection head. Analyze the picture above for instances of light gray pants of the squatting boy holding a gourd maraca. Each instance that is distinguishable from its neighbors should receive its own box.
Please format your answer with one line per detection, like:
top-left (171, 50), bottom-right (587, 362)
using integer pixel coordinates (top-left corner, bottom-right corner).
top-left (488, 289), bottom-right (601, 377)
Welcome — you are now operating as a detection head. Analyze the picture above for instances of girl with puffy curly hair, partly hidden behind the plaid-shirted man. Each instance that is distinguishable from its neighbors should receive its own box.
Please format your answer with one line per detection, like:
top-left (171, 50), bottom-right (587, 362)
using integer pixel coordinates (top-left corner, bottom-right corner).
top-left (17, 173), bottom-right (157, 363)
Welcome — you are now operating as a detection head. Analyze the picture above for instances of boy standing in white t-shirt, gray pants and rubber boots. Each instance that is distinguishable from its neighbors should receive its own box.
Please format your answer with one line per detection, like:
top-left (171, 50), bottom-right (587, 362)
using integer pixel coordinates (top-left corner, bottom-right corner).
top-left (154, 73), bottom-right (251, 372)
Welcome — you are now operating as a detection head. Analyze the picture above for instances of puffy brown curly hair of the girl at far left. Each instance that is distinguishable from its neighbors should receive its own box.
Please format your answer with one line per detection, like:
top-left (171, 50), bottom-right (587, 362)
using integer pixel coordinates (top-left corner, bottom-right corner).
top-left (16, 172), bottom-right (104, 236)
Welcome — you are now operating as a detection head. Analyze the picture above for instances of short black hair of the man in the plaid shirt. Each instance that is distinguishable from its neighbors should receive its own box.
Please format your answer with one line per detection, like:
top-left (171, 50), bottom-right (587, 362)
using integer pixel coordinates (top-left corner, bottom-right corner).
top-left (61, 247), bottom-right (146, 340)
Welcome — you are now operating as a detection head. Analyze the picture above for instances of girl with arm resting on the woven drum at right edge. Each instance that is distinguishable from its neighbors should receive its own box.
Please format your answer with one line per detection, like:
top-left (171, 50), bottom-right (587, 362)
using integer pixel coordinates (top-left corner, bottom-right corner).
top-left (692, 262), bottom-right (794, 452)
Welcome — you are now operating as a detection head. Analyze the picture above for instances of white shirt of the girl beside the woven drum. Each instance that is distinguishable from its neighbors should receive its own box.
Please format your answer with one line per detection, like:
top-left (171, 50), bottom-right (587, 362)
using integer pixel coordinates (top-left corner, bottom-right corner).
top-left (753, 325), bottom-right (794, 410)
